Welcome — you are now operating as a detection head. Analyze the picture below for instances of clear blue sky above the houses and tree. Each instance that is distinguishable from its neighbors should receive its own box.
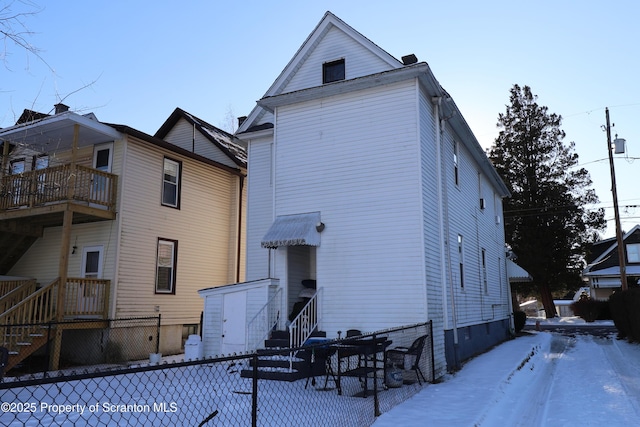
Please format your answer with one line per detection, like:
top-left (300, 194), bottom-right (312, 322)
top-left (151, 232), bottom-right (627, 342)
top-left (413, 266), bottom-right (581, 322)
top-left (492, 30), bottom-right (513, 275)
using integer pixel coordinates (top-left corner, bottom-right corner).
top-left (0, 0), bottom-right (640, 237)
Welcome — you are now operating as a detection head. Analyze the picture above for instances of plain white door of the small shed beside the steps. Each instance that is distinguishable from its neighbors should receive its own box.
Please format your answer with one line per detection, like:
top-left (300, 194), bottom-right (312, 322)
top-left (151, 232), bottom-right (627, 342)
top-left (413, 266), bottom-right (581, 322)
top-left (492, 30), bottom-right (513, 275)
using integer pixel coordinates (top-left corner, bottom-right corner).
top-left (222, 292), bottom-right (247, 355)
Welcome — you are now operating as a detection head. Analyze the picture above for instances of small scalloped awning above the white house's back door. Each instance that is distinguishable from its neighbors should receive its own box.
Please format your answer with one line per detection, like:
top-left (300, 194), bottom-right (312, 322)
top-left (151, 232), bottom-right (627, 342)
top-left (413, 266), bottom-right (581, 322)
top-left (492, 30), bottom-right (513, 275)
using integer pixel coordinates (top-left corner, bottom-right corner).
top-left (261, 212), bottom-right (320, 249)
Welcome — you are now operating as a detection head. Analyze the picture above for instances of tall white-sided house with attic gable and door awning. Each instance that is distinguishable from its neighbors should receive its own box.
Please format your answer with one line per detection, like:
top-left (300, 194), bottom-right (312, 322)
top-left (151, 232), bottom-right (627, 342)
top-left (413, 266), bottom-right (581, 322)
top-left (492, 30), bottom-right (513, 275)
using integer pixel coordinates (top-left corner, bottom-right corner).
top-left (201, 12), bottom-right (511, 376)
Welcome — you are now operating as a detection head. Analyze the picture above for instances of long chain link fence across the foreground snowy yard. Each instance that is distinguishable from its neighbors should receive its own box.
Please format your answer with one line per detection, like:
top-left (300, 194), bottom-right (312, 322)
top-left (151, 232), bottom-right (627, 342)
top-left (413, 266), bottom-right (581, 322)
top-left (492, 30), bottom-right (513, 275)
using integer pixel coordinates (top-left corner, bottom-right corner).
top-left (0, 323), bottom-right (434, 427)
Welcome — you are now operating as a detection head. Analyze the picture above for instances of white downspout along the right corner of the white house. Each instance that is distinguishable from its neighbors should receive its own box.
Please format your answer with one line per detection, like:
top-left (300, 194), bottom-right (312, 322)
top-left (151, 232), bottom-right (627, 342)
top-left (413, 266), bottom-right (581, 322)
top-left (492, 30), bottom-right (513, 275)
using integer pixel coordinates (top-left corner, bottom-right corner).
top-left (432, 96), bottom-right (458, 367)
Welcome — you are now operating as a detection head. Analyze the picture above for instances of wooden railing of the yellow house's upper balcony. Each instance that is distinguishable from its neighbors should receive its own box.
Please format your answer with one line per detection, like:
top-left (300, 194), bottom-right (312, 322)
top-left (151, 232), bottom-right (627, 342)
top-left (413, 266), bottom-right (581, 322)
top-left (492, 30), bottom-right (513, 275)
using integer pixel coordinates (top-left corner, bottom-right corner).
top-left (0, 164), bottom-right (117, 211)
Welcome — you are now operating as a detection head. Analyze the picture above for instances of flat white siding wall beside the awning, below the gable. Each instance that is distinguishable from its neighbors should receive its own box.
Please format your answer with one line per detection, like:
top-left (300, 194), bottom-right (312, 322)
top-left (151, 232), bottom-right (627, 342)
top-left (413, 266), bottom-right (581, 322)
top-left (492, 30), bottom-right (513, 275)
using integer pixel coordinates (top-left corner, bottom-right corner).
top-left (272, 81), bottom-right (426, 335)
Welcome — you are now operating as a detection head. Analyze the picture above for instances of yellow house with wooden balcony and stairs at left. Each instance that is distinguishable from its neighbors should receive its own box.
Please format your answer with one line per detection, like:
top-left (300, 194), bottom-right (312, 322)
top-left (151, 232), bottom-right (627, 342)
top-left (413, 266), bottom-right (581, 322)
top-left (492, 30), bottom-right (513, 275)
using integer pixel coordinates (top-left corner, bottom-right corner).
top-left (0, 104), bottom-right (246, 372)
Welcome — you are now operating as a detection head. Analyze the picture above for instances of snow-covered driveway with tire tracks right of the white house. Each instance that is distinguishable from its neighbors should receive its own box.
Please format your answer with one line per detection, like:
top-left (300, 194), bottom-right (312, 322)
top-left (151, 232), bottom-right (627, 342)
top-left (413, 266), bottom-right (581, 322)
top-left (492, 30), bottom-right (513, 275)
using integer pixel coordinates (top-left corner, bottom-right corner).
top-left (374, 317), bottom-right (640, 427)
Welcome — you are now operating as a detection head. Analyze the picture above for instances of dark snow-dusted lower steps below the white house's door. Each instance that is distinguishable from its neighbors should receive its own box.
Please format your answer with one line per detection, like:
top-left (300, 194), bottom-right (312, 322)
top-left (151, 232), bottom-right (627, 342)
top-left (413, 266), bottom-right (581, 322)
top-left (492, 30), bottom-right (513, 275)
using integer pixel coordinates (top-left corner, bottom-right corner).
top-left (240, 331), bottom-right (327, 382)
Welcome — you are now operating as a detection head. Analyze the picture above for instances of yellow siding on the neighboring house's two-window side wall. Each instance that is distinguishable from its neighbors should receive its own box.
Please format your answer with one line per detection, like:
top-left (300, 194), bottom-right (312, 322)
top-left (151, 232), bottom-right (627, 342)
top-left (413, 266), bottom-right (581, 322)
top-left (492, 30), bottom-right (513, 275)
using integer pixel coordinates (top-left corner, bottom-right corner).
top-left (116, 138), bottom-right (238, 325)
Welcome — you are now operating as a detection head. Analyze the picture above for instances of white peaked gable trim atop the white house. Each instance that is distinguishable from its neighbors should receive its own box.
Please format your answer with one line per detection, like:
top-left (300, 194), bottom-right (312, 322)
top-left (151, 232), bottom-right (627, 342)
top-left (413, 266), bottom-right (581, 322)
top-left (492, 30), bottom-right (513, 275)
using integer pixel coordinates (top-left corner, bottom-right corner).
top-left (237, 11), bottom-right (403, 133)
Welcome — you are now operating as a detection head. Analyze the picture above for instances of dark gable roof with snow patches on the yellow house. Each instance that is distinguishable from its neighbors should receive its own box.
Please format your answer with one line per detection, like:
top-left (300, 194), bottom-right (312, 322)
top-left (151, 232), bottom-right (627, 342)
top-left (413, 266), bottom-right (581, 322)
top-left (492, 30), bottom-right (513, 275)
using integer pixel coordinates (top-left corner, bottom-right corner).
top-left (154, 107), bottom-right (247, 167)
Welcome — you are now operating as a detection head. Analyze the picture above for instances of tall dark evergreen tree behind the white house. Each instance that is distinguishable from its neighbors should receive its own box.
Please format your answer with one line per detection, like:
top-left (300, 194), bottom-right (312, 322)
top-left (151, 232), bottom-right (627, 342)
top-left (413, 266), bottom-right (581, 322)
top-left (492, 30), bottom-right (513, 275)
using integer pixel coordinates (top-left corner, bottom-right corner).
top-left (489, 85), bottom-right (605, 317)
